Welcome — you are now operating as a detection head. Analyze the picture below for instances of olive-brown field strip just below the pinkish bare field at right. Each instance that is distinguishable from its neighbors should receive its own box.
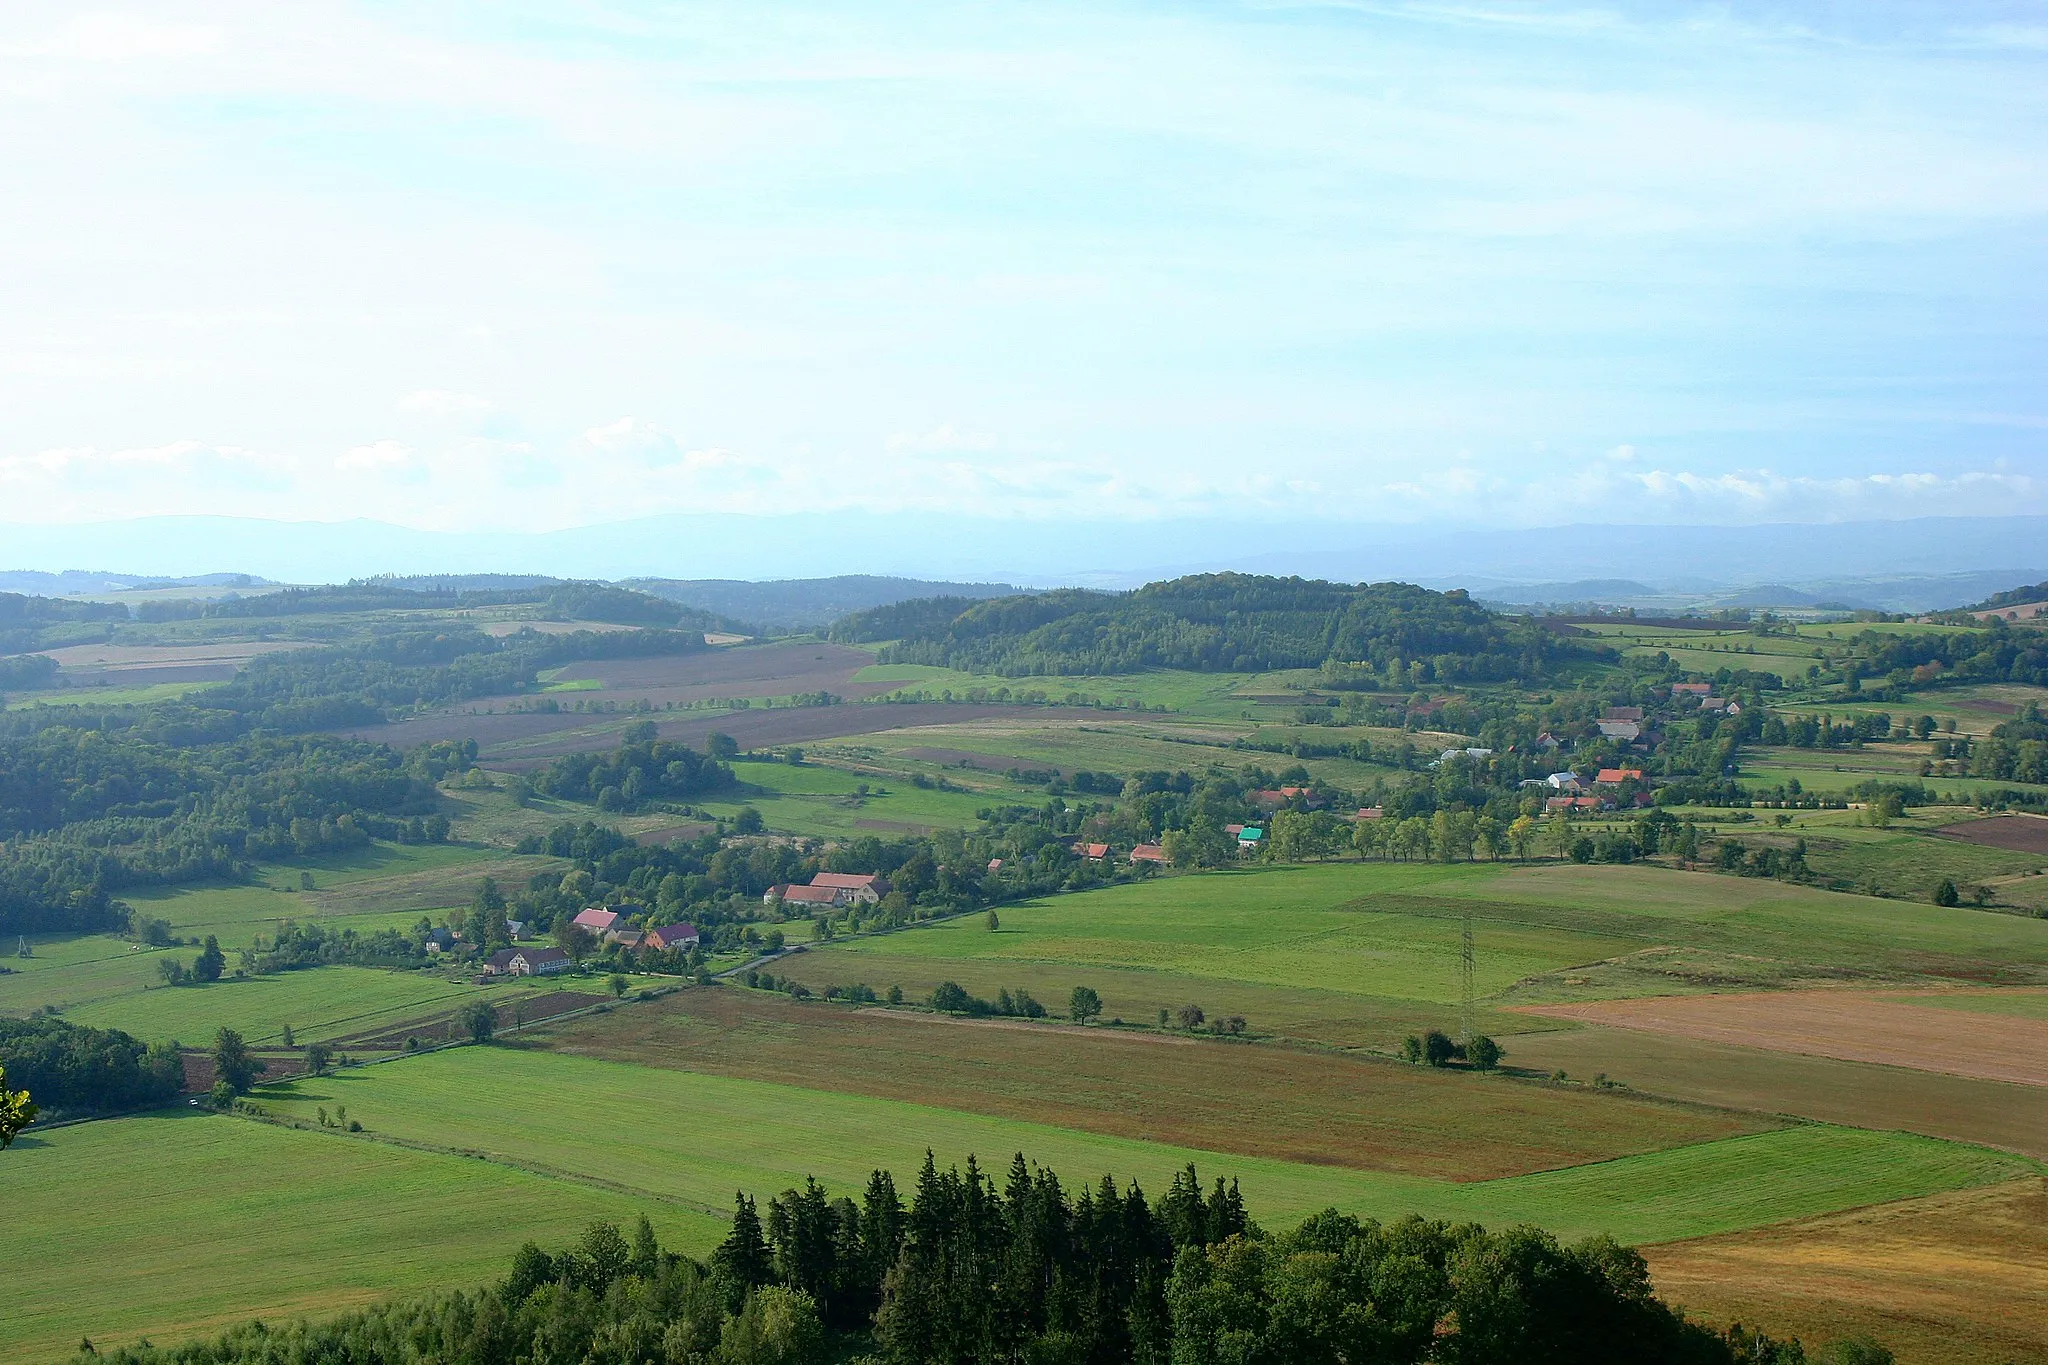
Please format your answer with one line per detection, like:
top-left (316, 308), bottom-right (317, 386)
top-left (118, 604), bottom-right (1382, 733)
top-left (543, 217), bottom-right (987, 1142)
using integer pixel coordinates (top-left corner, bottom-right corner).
top-left (1501, 1027), bottom-right (2048, 1160)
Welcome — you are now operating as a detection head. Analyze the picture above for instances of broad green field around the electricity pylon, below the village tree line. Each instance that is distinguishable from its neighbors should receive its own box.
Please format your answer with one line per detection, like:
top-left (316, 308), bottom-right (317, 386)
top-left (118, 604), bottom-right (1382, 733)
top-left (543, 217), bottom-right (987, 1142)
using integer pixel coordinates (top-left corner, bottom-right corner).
top-left (778, 864), bottom-right (2048, 1046)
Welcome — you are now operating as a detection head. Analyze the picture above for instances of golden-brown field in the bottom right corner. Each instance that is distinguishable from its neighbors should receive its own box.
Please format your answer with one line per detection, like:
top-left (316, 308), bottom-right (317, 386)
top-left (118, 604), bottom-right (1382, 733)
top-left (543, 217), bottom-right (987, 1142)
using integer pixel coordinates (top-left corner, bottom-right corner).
top-left (1645, 1179), bottom-right (2048, 1365)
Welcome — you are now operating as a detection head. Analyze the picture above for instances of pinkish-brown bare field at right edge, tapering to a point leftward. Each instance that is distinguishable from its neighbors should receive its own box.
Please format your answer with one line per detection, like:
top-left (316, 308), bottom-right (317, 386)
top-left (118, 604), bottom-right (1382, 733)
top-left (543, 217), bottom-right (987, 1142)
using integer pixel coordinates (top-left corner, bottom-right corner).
top-left (1520, 990), bottom-right (2048, 1085)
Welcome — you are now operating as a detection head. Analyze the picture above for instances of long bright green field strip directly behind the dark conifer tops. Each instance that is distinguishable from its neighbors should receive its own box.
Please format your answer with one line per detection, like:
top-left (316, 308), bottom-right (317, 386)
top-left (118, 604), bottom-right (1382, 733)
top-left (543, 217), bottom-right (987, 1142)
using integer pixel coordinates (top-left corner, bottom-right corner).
top-left (266, 1048), bottom-right (2038, 1242)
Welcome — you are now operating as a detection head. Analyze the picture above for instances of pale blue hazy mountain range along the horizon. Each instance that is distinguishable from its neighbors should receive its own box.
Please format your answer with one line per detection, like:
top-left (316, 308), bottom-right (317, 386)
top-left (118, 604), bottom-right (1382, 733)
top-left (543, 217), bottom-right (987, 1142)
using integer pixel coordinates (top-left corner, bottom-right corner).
top-left (0, 512), bottom-right (2048, 628)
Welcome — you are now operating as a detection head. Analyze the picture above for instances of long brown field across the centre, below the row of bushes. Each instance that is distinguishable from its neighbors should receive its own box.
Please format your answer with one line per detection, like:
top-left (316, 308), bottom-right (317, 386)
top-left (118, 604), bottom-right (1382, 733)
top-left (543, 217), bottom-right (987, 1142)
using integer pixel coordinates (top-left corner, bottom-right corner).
top-left (516, 986), bottom-right (1776, 1181)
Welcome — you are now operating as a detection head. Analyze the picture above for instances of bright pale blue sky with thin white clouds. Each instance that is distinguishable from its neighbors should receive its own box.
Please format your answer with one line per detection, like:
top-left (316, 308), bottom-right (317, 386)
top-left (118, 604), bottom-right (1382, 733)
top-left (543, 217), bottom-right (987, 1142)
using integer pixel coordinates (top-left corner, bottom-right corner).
top-left (0, 0), bottom-right (2048, 532)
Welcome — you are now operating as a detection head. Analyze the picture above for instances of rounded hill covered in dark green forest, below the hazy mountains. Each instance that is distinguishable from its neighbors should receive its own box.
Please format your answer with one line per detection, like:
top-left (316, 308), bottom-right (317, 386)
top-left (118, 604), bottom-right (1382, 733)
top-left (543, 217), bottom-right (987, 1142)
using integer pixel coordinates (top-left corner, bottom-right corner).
top-left (831, 573), bottom-right (1593, 686)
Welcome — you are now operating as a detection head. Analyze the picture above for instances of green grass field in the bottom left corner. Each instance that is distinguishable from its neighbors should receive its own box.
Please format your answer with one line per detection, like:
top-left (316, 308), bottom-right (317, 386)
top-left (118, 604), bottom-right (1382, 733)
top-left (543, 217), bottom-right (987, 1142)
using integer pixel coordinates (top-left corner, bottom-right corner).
top-left (0, 1111), bottom-right (723, 1361)
